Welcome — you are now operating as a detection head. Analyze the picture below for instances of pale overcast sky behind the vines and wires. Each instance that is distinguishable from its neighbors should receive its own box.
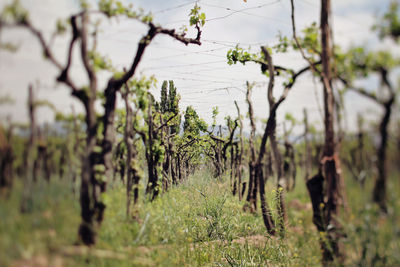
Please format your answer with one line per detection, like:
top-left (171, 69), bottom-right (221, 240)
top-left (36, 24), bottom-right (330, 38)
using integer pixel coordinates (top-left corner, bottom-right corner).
top-left (0, 0), bottom-right (392, 134)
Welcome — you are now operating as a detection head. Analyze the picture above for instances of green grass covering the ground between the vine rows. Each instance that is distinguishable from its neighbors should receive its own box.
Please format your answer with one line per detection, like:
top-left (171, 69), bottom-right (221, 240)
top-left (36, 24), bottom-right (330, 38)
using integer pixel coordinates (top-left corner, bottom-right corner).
top-left (0, 171), bottom-right (400, 266)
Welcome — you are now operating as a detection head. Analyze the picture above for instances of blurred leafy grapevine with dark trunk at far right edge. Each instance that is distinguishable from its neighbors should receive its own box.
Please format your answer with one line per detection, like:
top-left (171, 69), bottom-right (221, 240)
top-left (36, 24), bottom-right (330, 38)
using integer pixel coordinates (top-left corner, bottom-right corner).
top-left (339, 47), bottom-right (400, 212)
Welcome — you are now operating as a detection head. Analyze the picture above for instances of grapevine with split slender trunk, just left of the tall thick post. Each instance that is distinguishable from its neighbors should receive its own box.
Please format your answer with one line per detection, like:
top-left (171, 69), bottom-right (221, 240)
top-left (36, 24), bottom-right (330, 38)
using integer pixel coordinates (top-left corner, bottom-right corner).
top-left (227, 39), bottom-right (317, 234)
